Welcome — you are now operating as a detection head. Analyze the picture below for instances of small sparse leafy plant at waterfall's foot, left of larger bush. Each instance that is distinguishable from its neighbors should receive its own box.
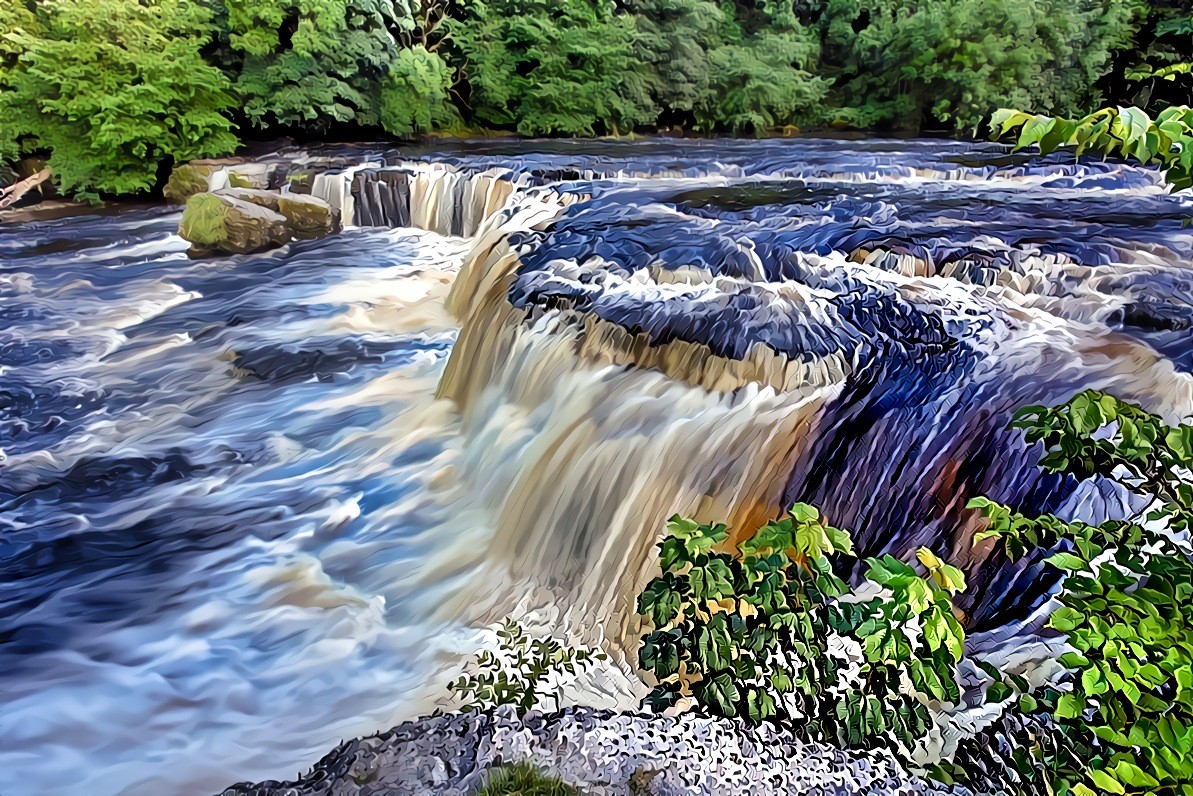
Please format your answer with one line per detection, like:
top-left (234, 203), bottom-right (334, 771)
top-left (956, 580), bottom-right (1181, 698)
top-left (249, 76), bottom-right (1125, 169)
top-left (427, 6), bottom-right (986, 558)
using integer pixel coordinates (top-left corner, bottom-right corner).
top-left (447, 619), bottom-right (605, 714)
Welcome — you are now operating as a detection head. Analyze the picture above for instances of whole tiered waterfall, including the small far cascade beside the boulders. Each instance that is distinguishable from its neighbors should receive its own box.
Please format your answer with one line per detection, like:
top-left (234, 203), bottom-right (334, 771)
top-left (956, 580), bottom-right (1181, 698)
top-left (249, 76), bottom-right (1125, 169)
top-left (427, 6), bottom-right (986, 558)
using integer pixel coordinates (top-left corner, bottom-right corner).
top-left (205, 146), bottom-right (1193, 637)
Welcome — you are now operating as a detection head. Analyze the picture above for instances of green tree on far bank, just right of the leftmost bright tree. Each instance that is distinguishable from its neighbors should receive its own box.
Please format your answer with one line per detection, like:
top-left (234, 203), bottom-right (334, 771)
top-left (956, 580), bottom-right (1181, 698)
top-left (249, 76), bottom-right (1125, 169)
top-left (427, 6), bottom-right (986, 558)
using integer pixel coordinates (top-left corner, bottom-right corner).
top-left (223, 0), bottom-right (413, 129)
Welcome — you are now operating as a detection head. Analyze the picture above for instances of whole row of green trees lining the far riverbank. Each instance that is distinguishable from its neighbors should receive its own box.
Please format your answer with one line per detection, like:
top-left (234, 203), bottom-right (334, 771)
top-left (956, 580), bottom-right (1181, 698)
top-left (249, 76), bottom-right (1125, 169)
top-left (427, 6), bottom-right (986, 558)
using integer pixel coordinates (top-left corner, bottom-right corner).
top-left (0, 0), bottom-right (1173, 193)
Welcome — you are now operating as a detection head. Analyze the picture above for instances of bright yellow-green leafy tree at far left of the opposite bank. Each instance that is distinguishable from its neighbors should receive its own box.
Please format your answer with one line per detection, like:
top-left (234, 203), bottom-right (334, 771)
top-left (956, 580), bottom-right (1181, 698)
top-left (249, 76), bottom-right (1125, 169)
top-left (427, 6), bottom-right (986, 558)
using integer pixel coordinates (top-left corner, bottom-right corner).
top-left (0, 0), bottom-right (237, 197)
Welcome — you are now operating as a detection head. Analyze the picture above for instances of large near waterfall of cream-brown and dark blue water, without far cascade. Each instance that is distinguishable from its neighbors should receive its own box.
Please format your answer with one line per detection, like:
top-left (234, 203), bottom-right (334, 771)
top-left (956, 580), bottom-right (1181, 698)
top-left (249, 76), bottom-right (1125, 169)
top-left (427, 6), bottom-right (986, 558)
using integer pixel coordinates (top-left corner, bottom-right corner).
top-left (431, 158), bottom-right (1193, 640)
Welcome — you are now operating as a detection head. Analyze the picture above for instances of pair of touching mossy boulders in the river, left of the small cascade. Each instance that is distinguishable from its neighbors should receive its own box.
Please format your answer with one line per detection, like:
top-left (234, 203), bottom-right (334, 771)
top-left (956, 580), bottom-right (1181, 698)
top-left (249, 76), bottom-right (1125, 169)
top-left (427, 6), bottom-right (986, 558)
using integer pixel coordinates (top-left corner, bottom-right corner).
top-left (178, 187), bottom-right (341, 257)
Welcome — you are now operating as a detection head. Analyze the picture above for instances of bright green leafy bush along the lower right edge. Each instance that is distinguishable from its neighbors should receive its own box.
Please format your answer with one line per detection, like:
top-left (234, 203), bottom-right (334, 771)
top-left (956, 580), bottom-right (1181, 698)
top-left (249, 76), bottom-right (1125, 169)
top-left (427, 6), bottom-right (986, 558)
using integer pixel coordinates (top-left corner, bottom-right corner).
top-left (970, 391), bottom-right (1193, 796)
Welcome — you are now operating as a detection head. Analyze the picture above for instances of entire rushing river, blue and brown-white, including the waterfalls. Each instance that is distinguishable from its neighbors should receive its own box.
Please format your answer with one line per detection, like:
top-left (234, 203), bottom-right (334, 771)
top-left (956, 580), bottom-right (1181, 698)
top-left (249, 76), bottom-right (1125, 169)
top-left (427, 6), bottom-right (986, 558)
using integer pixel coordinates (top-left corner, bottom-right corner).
top-left (0, 141), bottom-right (1193, 796)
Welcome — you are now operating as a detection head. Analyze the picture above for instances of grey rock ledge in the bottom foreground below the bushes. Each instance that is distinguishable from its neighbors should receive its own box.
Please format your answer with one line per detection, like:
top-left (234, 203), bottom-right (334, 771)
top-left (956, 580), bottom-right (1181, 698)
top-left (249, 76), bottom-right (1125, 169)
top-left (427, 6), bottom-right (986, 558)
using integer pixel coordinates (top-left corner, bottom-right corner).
top-left (222, 708), bottom-right (970, 796)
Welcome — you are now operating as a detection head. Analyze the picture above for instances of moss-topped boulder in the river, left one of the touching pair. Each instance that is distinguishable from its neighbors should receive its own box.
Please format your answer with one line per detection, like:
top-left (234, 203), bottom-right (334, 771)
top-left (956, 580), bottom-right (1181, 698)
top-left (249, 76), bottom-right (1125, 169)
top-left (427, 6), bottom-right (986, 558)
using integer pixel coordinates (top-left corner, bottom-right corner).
top-left (178, 193), bottom-right (291, 257)
